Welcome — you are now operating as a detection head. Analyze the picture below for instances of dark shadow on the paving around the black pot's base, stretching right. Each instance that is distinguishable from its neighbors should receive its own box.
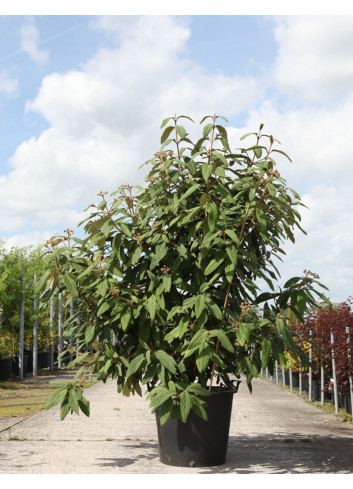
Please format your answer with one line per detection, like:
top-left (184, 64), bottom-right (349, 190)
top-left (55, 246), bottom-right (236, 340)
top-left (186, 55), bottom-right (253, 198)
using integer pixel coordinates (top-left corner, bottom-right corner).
top-left (93, 433), bottom-right (353, 474)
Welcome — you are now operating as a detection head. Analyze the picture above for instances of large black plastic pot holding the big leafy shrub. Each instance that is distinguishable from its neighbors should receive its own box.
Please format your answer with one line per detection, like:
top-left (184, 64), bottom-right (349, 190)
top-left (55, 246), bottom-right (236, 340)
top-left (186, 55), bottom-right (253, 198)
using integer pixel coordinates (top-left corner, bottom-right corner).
top-left (156, 383), bottom-right (239, 467)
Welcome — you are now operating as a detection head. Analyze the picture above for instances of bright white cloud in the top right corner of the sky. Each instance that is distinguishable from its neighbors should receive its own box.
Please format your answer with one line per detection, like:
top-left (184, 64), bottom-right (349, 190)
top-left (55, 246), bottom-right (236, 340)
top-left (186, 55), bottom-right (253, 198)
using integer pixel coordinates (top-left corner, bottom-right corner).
top-left (274, 15), bottom-right (353, 104)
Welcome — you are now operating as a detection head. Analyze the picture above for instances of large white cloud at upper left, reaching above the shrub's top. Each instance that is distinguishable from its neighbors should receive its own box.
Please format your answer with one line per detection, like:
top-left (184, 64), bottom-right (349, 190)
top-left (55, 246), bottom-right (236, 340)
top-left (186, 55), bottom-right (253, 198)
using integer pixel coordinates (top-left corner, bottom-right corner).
top-left (0, 16), bottom-right (260, 241)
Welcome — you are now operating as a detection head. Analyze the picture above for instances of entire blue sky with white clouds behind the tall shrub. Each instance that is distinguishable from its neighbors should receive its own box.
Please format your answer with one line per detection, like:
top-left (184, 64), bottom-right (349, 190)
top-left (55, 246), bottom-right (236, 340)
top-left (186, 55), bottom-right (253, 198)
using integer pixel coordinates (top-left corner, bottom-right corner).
top-left (0, 4), bottom-right (353, 302)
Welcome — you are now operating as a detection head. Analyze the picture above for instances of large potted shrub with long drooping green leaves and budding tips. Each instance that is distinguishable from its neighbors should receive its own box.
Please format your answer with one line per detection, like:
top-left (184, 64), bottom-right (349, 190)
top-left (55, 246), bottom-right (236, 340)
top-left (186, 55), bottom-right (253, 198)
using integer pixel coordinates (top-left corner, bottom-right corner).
top-left (41, 116), bottom-right (324, 423)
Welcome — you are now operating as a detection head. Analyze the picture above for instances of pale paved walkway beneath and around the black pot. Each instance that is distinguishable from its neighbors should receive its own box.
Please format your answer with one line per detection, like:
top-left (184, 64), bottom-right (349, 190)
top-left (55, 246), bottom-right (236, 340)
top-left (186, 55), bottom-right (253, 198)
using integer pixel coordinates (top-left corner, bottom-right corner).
top-left (0, 379), bottom-right (353, 474)
